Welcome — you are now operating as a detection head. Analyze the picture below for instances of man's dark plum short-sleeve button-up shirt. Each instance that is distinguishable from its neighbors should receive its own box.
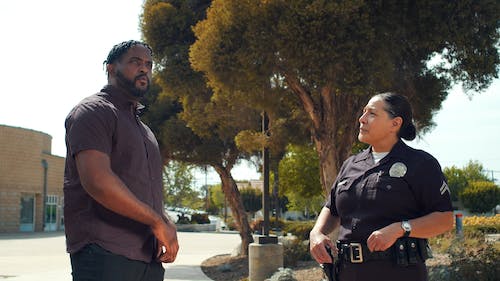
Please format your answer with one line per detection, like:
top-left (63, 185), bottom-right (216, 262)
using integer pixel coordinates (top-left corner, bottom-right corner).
top-left (64, 85), bottom-right (163, 262)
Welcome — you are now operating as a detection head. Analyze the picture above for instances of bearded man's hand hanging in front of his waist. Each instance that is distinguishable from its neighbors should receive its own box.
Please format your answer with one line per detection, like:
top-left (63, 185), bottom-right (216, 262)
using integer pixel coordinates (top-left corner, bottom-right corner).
top-left (151, 216), bottom-right (179, 263)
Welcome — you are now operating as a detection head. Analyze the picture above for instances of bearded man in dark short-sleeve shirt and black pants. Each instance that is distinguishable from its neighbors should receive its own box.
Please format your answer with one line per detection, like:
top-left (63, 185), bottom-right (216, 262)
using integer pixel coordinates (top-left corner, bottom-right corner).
top-left (64, 41), bottom-right (179, 281)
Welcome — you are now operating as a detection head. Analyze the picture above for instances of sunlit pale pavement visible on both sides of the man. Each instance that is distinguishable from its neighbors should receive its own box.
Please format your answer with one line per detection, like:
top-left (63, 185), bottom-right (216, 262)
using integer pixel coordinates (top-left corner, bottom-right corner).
top-left (0, 232), bottom-right (240, 281)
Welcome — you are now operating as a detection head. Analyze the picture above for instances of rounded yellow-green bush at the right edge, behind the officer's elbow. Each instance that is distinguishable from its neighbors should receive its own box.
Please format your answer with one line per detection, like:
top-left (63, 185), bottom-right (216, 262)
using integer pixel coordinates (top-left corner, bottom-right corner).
top-left (460, 181), bottom-right (500, 213)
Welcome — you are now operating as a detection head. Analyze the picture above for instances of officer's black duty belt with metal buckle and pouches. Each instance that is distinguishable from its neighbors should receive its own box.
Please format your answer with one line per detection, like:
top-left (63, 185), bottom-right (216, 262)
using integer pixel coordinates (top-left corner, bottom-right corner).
top-left (337, 238), bottom-right (432, 266)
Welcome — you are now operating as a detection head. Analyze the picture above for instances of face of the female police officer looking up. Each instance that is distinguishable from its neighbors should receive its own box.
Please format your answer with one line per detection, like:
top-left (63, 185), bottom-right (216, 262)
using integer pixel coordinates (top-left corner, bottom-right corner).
top-left (358, 97), bottom-right (402, 152)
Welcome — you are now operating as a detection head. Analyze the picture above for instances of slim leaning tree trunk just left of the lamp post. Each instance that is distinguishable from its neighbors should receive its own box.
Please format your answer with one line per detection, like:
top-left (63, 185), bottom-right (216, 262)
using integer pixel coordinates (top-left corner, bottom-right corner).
top-left (213, 165), bottom-right (253, 256)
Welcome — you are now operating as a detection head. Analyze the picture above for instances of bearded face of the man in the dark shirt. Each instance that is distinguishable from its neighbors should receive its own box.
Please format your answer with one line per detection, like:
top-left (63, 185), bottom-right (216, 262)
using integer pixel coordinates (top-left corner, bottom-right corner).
top-left (114, 45), bottom-right (153, 98)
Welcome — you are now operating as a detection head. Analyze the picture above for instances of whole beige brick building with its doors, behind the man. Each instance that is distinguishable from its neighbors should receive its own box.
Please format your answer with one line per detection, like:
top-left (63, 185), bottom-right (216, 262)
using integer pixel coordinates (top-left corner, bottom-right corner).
top-left (0, 125), bottom-right (64, 232)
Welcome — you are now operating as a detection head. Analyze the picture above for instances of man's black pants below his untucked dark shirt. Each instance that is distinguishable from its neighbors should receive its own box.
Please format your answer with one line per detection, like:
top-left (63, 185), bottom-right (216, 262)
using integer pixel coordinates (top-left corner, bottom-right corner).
top-left (70, 244), bottom-right (165, 281)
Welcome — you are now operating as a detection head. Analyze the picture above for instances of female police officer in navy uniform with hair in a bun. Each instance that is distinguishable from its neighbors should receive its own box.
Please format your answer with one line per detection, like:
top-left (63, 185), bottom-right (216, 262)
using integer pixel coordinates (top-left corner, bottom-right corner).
top-left (310, 93), bottom-right (453, 281)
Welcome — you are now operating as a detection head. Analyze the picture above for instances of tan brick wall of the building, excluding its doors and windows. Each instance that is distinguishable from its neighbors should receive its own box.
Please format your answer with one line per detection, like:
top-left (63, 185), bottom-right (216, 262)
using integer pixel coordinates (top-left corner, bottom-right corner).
top-left (0, 125), bottom-right (64, 232)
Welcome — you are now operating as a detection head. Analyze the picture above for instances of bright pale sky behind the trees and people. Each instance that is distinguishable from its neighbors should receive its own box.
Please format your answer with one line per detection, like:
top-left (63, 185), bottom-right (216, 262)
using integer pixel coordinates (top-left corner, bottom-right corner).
top-left (0, 0), bottom-right (500, 184)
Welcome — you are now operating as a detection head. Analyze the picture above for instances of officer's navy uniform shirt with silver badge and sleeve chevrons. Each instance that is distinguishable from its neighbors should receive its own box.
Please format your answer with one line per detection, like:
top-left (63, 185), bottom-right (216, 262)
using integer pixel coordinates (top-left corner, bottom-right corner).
top-left (325, 140), bottom-right (453, 242)
